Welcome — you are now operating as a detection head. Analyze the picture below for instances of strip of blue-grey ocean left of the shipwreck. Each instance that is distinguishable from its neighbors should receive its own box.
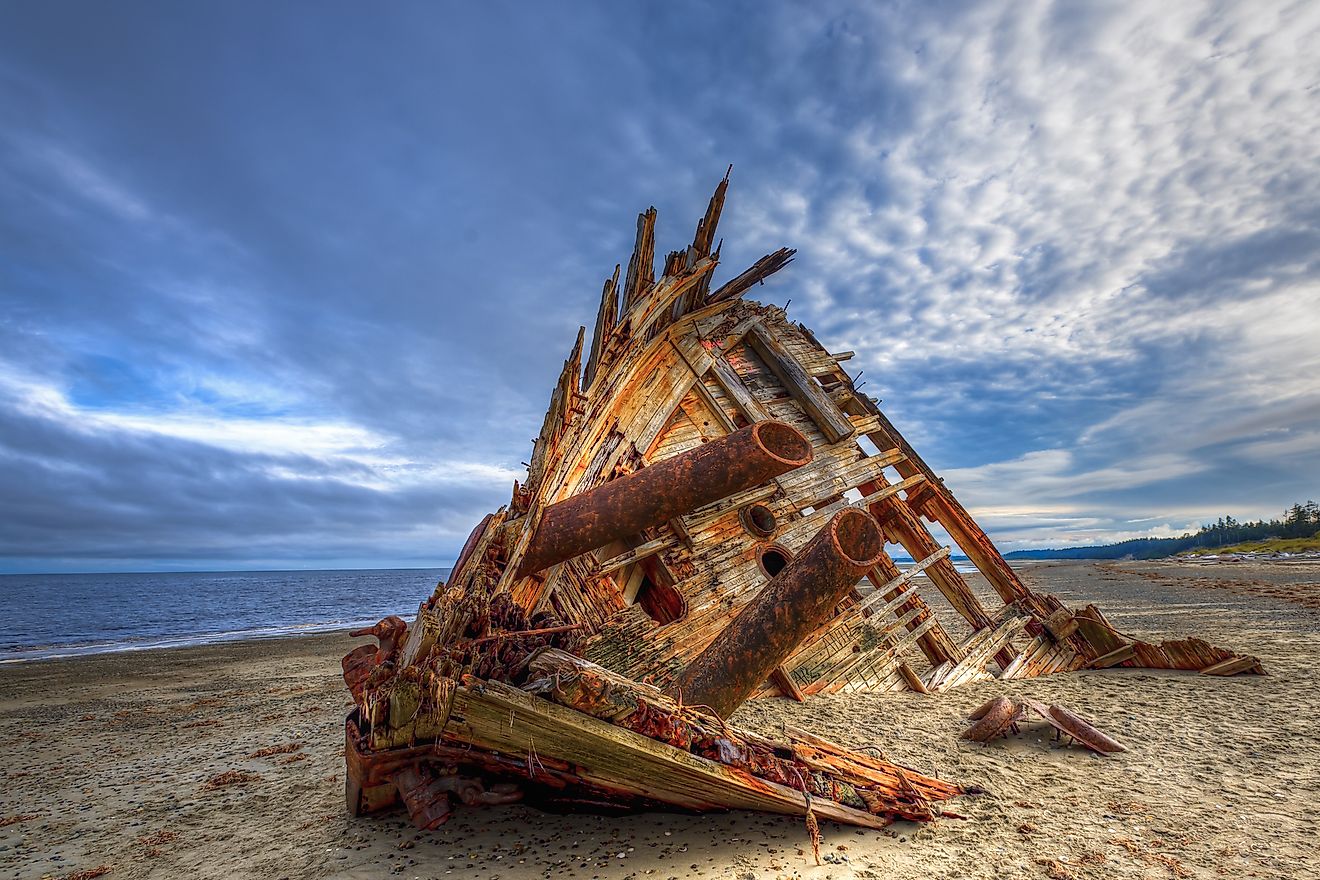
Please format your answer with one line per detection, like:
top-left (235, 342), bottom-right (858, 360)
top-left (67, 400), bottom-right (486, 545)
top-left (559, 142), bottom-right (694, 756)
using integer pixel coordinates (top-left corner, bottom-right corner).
top-left (0, 569), bottom-right (449, 662)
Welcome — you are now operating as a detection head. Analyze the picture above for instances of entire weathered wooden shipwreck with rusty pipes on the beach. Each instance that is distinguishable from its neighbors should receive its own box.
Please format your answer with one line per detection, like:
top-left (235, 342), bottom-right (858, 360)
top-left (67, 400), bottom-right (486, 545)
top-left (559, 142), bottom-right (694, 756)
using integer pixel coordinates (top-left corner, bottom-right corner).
top-left (343, 175), bottom-right (1262, 827)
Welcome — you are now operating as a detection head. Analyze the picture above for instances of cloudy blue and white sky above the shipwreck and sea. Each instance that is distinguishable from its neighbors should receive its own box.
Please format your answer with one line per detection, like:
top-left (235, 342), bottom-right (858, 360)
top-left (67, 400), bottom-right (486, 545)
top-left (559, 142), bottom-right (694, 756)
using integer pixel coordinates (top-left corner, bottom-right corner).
top-left (0, 0), bottom-right (1320, 571)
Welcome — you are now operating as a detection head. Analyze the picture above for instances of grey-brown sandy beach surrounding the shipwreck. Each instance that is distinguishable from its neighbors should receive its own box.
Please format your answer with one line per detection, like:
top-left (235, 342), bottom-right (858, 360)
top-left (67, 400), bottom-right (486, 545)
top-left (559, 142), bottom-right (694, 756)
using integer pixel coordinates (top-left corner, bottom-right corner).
top-left (0, 562), bottom-right (1320, 880)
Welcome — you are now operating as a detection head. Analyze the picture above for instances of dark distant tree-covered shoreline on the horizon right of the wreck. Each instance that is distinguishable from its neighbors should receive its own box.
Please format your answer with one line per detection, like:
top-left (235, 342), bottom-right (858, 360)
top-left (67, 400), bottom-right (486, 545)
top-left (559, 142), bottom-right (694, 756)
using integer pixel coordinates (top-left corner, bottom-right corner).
top-left (1005, 501), bottom-right (1320, 559)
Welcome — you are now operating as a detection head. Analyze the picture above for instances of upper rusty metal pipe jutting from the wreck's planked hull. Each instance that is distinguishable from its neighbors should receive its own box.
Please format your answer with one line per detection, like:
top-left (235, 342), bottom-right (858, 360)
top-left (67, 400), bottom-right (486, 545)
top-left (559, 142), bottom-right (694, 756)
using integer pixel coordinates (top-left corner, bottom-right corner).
top-left (517, 420), bottom-right (812, 578)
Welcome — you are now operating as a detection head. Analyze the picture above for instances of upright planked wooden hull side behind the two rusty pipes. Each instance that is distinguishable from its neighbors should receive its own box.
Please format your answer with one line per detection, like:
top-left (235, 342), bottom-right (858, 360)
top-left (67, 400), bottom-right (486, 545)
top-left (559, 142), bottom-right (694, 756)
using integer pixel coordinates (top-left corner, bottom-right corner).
top-left (418, 170), bottom-right (1259, 697)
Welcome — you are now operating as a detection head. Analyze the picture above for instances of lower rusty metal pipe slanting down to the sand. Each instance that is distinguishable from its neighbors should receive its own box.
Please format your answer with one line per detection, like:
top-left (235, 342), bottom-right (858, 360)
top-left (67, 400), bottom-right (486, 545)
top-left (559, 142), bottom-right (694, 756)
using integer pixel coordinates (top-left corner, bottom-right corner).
top-left (669, 507), bottom-right (884, 718)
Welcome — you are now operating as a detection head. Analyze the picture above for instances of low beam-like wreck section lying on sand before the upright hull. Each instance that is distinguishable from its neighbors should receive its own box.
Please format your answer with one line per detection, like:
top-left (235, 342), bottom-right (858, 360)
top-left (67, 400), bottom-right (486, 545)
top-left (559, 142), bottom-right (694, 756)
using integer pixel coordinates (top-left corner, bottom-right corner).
top-left (345, 577), bottom-right (965, 829)
